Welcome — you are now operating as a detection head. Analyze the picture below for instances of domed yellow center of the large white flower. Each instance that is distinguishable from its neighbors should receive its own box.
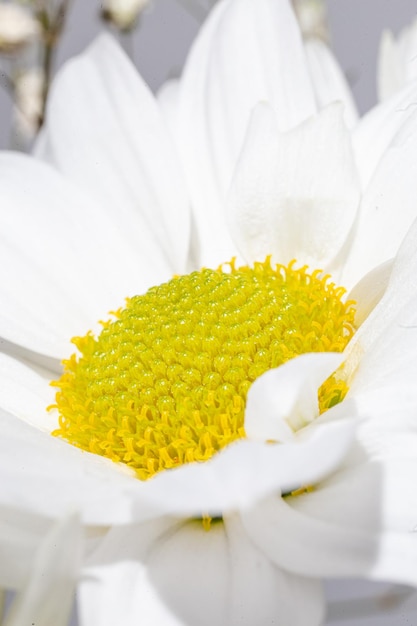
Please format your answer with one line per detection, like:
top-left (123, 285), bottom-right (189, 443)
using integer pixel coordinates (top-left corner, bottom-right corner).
top-left (52, 258), bottom-right (354, 480)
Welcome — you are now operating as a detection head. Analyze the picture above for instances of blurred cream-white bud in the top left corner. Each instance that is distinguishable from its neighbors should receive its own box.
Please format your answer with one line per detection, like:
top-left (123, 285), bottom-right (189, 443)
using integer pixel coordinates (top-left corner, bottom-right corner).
top-left (0, 3), bottom-right (40, 53)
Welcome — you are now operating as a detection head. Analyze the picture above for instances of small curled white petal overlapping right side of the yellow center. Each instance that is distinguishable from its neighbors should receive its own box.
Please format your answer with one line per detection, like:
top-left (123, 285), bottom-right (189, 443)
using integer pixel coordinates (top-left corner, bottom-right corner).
top-left (245, 352), bottom-right (343, 442)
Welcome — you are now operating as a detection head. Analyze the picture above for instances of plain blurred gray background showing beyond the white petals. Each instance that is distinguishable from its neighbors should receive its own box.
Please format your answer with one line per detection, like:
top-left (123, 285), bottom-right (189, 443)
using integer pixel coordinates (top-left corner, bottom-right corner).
top-left (0, 0), bottom-right (417, 626)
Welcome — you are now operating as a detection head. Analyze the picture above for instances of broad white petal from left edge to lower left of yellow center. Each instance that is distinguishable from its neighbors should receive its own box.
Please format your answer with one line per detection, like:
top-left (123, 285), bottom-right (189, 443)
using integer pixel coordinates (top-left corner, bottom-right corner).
top-left (0, 411), bottom-right (138, 524)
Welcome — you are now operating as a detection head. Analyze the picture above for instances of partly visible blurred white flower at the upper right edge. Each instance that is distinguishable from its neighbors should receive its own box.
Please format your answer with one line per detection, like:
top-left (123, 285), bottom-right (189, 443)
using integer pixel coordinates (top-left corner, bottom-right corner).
top-left (377, 20), bottom-right (417, 102)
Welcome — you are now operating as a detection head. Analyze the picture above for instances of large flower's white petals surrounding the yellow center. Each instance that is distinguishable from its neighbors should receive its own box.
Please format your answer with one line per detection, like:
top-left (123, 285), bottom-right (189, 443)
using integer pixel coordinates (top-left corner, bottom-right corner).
top-left (0, 0), bottom-right (417, 626)
